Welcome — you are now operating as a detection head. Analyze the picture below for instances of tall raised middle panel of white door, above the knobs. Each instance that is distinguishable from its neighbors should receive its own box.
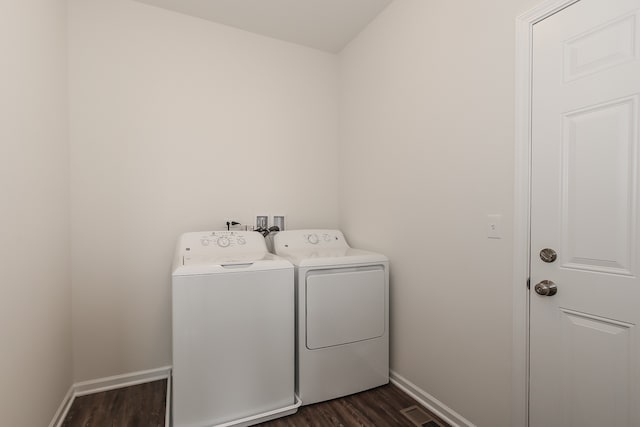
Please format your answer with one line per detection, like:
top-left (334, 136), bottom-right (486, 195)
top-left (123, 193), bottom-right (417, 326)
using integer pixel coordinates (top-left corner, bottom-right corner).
top-left (560, 95), bottom-right (638, 275)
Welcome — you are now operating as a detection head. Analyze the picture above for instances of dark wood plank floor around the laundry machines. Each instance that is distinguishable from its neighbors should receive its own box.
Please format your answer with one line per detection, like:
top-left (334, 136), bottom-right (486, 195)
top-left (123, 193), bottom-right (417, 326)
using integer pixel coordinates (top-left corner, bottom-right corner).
top-left (62, 380), bottom-right (448, 427)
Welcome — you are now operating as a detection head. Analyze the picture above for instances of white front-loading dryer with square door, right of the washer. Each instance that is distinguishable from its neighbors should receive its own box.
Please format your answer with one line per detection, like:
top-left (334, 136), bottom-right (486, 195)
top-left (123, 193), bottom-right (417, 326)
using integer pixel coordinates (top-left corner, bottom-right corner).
top-left (274, 230), bottom-right (389, 405)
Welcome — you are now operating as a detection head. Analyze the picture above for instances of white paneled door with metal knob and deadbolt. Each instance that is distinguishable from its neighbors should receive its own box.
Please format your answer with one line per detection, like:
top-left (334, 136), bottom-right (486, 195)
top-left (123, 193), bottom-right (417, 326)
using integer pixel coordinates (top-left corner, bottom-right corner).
top-left (529, 0), bottom-right (640, 427)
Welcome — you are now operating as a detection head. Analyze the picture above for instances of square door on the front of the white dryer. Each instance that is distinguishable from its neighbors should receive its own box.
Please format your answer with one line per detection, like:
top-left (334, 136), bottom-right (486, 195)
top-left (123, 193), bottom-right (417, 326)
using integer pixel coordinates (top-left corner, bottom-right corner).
top-left (306, 266), bottom-right (386, 350)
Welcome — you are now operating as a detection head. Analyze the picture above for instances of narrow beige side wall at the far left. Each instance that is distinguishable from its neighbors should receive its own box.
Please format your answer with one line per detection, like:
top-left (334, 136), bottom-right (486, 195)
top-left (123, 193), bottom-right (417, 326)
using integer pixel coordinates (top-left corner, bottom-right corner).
top-left (0, 0), bottom-right (71, 427)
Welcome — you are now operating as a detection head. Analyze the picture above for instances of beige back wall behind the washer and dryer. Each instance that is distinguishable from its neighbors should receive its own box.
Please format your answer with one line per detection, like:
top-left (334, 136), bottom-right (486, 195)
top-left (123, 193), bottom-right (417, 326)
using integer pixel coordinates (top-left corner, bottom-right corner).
top-left (69, 0), bottom-right (338, 381)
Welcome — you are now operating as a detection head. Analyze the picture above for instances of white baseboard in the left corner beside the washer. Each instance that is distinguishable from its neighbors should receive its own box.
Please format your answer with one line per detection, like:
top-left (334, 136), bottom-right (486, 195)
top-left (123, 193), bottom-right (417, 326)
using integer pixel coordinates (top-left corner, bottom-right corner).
top-left (49, 366), bottom-right (171, 427)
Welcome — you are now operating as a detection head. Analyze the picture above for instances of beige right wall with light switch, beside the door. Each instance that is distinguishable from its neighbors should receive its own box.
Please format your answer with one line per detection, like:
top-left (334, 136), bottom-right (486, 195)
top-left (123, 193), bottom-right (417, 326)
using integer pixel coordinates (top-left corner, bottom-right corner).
top-left (339, 0), bottom-right (539, 427)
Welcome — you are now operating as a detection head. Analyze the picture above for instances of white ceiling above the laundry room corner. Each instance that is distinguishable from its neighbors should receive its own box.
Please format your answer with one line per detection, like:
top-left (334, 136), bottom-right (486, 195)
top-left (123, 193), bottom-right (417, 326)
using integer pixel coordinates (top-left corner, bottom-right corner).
top-left (136, 0), bottom-right (394, 53)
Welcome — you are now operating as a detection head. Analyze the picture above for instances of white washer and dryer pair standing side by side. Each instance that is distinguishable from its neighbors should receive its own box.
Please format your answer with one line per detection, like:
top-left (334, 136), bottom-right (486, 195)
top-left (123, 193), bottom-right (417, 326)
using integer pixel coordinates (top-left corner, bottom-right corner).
top-left (172, 230), bottom-right (389, 426)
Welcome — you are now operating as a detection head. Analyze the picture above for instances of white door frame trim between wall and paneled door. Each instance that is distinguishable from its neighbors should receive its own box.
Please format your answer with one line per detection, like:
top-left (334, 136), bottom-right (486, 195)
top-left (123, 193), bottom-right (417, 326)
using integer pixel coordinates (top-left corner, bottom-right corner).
top-left (511, 0), bottom-right (580, 427)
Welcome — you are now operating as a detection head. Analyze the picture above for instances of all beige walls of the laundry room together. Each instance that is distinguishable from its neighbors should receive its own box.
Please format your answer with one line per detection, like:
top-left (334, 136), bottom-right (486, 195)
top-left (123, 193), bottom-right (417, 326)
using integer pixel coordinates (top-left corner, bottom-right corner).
top-left (0, 0), bottom-right (552, 427)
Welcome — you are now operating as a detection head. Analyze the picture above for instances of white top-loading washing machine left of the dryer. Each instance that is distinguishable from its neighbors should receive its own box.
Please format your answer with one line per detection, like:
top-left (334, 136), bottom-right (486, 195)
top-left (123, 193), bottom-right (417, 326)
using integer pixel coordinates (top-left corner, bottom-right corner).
top-left (172, 231), bottom-right (300, 427)
